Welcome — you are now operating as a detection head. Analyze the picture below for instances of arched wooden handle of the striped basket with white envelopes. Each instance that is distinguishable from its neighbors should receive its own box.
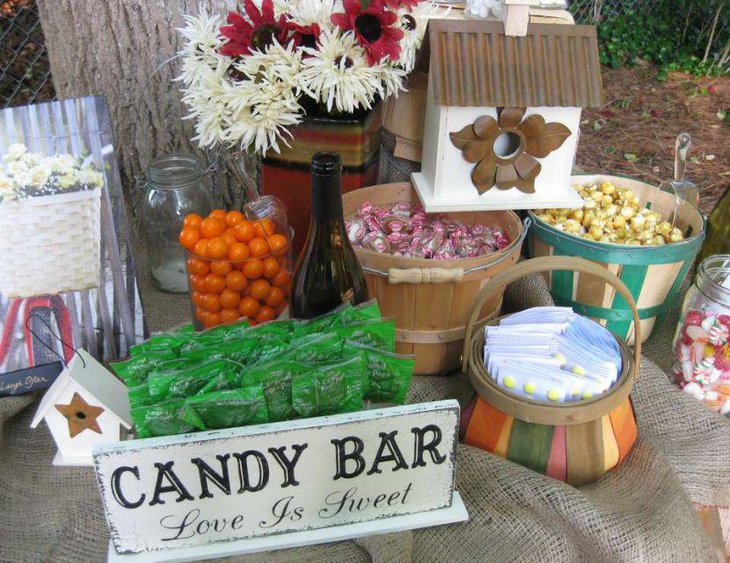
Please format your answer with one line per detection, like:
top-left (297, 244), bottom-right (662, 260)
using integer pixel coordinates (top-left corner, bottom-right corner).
top-left (461, 256), bottom-right (641, 373)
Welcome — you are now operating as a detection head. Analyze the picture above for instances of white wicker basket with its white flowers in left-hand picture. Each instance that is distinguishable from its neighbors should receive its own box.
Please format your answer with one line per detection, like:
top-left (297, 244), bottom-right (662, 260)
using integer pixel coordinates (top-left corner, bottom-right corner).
top-left (0, 144), bottom-right (104, 298)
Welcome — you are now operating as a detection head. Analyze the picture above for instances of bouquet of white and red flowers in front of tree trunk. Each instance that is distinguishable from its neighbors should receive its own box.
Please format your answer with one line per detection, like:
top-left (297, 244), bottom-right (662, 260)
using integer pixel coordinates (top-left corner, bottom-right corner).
top-left (177, 0), bottom-right (436, 154)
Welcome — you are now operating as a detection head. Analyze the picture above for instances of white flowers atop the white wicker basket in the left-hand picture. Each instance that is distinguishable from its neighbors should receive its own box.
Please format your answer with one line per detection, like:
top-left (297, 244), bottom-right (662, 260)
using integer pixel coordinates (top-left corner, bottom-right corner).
top-left (0, 143), bottom-right (104, 203)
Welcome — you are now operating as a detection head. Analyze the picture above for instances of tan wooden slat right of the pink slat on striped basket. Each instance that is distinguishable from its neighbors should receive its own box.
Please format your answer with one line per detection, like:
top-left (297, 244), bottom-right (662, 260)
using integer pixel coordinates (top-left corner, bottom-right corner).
top-left (565, 419), bottom-right (606, 486)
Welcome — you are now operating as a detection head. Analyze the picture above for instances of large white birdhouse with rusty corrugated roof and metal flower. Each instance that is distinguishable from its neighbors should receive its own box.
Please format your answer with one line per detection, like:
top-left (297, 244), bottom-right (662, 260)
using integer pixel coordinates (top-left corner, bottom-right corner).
top-left (412, 18), bottom-right (603, 212)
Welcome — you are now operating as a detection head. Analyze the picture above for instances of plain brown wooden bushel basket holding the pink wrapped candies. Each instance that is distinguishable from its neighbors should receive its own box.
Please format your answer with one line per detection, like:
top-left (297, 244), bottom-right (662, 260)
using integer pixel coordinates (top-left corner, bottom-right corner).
top-left (343, 183), bottom-right (525, 374)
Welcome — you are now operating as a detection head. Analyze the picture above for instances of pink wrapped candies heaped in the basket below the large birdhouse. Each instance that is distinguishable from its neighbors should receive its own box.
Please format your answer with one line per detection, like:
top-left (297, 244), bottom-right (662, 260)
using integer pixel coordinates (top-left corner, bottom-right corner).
top-left (347, 201), bottom-right (510, 260)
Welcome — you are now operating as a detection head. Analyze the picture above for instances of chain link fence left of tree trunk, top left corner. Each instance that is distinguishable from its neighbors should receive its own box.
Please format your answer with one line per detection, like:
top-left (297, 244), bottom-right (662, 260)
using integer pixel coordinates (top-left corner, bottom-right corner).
top-left (0, 0), bottom-right (56, 108)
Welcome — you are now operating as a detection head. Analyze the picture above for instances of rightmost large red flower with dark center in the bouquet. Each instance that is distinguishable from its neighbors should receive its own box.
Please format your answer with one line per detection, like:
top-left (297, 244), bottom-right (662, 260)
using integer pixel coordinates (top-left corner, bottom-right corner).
top-left (330, 0), bottom-right (403, 66)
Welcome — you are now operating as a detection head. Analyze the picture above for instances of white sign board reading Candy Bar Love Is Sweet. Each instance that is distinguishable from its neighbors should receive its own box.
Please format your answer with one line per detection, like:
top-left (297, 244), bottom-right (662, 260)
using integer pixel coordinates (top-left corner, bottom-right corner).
top-left (94, 401), bottom-right (459, 554)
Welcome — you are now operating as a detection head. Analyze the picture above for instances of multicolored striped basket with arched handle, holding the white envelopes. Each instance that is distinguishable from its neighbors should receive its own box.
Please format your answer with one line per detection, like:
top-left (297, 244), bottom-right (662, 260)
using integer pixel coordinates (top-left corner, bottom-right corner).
top-left (461, 258), bottom-right (641, 485)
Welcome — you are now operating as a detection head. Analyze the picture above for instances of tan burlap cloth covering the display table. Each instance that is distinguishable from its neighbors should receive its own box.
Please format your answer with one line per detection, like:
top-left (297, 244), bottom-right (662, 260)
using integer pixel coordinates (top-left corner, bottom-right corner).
top-left (0, 269), bottom-right (730, 563)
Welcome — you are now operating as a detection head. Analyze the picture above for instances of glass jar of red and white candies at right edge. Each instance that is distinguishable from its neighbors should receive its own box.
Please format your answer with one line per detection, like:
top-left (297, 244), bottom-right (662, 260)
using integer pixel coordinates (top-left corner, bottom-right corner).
top-left (672, 254), bottom-right (730, 416)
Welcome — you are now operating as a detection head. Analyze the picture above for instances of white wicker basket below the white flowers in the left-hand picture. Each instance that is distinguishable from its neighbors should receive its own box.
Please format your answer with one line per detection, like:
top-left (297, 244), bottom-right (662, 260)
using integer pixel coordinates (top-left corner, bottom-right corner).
top-left (0, 189), bottom-right (101, 297)
